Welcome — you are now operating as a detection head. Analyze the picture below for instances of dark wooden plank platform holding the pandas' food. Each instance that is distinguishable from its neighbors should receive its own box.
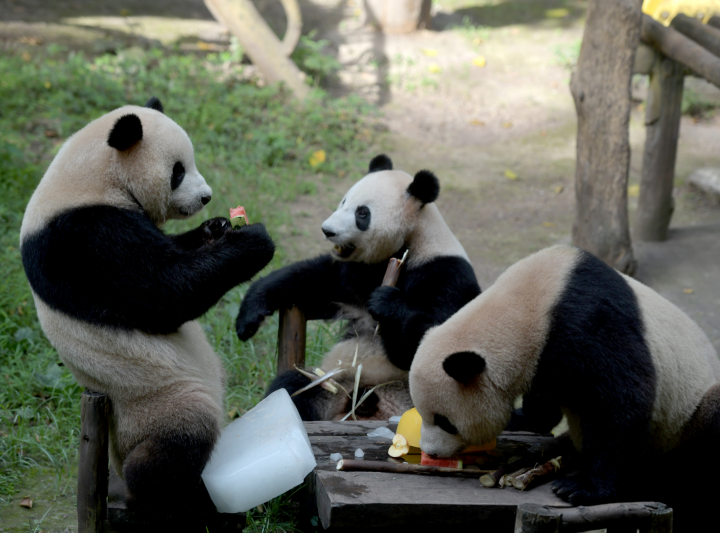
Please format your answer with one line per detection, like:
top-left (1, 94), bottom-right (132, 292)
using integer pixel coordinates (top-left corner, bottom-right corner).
top-left (300, 422), bottom-right (570, 532)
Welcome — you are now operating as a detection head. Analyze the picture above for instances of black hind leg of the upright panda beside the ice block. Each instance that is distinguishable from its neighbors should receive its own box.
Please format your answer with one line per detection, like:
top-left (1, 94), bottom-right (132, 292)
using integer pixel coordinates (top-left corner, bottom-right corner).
top-left (123, 432), bottom-right (217, 520)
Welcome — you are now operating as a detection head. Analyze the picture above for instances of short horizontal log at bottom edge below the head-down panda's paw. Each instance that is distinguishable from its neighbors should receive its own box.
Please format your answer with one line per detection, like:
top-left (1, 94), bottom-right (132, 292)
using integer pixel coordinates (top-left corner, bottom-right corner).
top-left (559, 502), bottom-right (672, 533)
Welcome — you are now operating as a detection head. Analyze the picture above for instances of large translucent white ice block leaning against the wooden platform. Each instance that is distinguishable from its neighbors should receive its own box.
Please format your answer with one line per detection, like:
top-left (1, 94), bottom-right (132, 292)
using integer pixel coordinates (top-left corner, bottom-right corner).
top-left (202, 389), bottom-right (317, 513)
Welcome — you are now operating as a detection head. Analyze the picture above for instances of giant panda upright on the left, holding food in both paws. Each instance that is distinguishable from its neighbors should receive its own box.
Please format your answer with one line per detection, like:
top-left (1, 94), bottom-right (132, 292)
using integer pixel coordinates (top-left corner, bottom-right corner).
top-left (20, 98), bottom-right (274, 514)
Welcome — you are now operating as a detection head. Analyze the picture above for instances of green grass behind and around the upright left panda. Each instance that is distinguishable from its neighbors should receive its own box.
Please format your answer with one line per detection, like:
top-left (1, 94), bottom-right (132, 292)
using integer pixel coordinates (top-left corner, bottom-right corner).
top-left (0, 45), bottom-right (376, 531)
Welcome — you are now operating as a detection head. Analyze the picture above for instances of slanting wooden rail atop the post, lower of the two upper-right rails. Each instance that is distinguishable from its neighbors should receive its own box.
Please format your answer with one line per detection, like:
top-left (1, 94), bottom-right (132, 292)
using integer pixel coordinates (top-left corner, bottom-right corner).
top-left (640, 15), bottom-right (720, 87)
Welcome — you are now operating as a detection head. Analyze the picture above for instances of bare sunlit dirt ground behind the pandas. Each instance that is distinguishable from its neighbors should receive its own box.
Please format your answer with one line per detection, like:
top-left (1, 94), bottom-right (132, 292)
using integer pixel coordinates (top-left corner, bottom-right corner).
top-left (0, 0), bottom-right (720, 531)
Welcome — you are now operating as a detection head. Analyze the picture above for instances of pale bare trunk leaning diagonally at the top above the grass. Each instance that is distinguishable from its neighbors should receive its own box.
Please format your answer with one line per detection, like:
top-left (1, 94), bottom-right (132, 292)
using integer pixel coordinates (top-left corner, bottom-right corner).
top-left (204, 0), bottom-right (309, 99)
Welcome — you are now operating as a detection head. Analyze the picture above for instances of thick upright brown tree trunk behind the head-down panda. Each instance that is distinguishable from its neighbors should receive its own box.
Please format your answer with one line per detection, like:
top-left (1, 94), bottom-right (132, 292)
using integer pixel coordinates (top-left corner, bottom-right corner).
top-left (570, 0), bottom-right (642, 274)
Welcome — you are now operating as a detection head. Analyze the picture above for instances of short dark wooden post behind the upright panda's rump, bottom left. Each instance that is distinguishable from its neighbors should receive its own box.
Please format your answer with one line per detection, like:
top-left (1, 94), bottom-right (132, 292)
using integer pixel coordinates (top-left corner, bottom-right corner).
top-left (77, 390), bottom-right (110, 533)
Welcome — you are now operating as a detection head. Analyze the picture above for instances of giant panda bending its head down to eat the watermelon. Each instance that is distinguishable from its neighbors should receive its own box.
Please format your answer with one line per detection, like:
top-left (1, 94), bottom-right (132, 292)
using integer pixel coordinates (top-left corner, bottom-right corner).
top-left (410, 246), bottom-right (720, 504)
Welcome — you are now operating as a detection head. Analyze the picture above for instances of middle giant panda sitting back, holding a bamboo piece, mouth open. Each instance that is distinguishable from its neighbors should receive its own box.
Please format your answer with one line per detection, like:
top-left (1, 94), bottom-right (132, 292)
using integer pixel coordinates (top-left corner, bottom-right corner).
top-left (237, 155), bottom-right (480, 420)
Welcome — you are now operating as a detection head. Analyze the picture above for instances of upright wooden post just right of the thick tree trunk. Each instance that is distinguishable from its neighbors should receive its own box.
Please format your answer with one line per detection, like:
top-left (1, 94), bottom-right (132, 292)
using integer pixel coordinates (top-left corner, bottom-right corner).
top-left (633, 54), bottom-right (685, 241)
